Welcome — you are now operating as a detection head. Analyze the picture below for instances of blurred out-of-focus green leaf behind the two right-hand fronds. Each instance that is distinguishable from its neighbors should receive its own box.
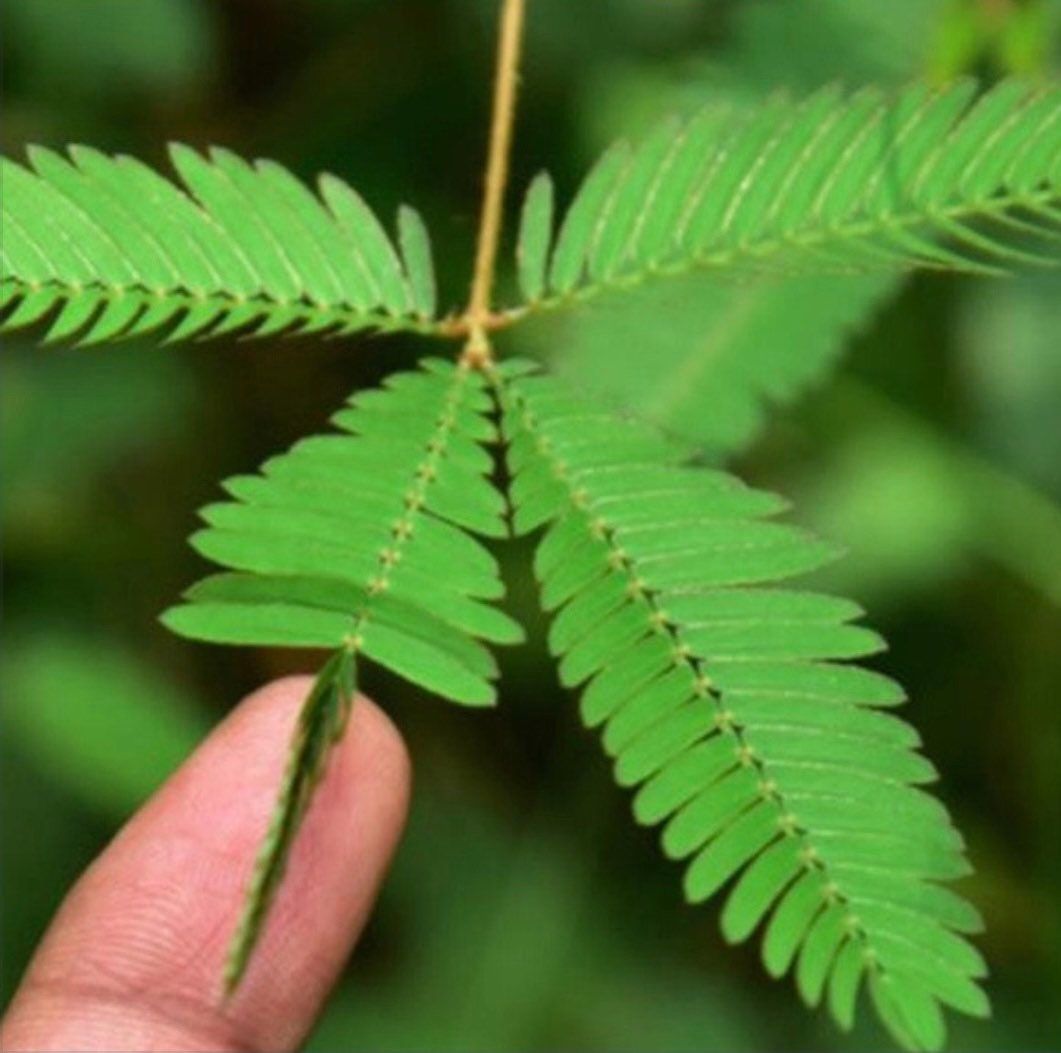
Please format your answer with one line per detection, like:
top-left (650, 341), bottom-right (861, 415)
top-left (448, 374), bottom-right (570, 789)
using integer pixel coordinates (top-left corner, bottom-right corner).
top-left (520, 267), bottom-right (901, 456)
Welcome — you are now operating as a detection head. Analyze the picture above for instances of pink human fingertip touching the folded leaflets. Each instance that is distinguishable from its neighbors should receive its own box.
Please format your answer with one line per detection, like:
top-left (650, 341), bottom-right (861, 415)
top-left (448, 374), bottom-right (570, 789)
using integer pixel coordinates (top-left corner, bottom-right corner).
top-left (0, 677), bottom-right (410, 1053)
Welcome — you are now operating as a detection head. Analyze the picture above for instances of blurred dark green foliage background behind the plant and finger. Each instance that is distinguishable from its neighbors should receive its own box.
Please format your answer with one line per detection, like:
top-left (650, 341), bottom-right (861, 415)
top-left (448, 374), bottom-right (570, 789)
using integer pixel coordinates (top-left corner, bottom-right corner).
top-left (0, 0), bottom-right (1061, 1053)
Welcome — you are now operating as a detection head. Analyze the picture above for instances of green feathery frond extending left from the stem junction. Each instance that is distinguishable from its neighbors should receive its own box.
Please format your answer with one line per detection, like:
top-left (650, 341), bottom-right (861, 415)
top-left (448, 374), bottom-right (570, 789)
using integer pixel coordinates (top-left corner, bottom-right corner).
top-left (0, 144), bottom-right (436, 344)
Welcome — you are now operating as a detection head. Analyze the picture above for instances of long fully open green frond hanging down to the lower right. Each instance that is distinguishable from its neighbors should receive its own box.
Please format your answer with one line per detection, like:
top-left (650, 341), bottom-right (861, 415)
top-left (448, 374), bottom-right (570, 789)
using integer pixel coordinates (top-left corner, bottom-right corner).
top-left (495, 363), bottom-right (988, 1050)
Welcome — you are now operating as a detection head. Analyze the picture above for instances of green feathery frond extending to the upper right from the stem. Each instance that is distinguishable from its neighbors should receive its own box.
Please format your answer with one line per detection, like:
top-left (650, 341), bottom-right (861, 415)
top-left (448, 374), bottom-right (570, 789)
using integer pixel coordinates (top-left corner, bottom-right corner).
top-left (520, 80), bottom-right (1061, 310)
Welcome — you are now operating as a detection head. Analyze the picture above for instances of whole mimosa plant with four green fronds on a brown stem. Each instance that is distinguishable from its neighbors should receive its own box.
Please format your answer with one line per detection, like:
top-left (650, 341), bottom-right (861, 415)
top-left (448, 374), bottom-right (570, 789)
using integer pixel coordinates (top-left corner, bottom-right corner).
top-left (0, 0), bottom-right (1061, 1049)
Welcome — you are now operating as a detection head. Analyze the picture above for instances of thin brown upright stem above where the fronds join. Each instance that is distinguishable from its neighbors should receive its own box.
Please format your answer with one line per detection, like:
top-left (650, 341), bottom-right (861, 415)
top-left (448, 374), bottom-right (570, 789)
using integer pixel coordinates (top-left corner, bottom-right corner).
top-left (463, 0), bottom-right (526, 366)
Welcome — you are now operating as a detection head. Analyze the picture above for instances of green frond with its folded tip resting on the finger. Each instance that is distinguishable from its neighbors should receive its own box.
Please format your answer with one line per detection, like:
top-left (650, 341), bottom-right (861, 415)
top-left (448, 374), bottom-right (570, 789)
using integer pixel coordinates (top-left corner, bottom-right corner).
top-left (162, 360), bottom-right (522, 989)
